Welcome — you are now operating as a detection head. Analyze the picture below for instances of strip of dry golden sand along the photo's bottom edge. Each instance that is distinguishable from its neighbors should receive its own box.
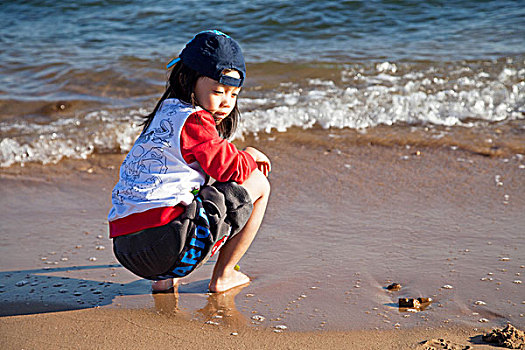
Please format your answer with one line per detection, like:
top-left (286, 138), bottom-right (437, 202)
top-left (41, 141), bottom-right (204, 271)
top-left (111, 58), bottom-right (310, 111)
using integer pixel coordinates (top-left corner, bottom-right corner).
top-left (0, 309), bottom-right (510, 349)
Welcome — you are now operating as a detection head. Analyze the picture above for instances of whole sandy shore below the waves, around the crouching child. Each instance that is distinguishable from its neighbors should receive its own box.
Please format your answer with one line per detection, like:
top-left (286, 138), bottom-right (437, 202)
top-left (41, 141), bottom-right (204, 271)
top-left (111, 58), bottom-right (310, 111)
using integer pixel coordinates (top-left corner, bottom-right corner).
top-left (0, 129), bottom-right (525, 349)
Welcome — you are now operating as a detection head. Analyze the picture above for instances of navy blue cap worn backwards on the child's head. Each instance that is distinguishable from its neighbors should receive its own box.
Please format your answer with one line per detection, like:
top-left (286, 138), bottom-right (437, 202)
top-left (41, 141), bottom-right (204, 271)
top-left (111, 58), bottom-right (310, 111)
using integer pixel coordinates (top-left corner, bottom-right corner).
top-left (166, 30), bottom-right (246, 87)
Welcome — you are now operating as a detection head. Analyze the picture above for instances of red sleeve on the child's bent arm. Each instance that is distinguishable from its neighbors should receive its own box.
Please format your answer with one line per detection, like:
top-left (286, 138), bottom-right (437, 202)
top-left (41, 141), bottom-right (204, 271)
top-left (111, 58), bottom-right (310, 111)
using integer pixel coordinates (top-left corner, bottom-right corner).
top-left (180, 111), bottom-right (257, 183)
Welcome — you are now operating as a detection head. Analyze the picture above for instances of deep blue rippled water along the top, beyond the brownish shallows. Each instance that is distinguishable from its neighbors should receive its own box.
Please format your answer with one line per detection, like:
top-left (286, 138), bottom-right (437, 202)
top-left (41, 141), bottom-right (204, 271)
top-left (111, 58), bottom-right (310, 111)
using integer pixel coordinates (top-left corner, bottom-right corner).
top-left (0, 0), bottom-right (525, 69)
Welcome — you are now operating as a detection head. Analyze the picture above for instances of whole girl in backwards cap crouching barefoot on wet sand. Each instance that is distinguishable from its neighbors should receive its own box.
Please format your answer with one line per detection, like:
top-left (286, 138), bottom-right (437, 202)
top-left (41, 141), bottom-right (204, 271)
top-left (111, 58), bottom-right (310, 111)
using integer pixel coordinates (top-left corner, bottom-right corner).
top-left (108, 31), bottom-right (270, 292)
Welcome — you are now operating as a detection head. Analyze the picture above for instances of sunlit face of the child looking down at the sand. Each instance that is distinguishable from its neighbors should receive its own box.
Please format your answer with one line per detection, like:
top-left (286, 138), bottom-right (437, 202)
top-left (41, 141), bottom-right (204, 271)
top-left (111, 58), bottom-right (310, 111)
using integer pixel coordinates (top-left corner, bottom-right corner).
top-left (195, 70), bottom-right (241, 124)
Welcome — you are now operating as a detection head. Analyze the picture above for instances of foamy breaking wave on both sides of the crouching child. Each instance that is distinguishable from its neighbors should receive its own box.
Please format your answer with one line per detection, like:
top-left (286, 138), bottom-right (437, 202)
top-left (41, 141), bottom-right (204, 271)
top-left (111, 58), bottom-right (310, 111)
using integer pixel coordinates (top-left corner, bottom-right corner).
top-left (0, 57), bottom-right (525, 167)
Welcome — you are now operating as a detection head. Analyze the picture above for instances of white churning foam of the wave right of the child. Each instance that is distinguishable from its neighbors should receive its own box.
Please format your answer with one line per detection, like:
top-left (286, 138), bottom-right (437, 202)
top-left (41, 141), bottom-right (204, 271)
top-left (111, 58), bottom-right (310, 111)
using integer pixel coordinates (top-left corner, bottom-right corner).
top-left (236, 62), bottom-right (525, 133)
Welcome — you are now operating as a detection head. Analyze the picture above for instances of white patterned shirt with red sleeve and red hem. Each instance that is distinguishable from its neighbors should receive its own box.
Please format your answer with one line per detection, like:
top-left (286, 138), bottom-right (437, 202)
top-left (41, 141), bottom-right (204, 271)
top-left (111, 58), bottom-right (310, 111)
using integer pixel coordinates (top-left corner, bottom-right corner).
top-left (108, 99), bottom-right (257, 238)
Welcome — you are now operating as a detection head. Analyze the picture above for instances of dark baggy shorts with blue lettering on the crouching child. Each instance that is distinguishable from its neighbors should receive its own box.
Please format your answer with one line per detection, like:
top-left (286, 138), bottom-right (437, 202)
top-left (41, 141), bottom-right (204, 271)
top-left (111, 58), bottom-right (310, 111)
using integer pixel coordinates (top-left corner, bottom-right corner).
top-left (113, 182), bottom-right (253, 280)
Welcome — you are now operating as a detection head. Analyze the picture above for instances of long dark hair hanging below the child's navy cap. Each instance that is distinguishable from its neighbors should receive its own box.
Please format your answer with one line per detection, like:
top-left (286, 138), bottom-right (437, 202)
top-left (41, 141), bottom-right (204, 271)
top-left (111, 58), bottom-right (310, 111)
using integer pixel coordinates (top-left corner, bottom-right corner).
top-left (142, 61), bottom-right (240, 139)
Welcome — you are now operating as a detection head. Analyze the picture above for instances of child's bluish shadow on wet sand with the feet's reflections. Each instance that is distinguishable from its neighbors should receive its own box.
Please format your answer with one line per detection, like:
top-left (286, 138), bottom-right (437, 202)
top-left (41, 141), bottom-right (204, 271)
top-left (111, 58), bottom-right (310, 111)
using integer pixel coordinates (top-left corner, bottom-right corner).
top-left (0, 264), bottom-right (242, 319)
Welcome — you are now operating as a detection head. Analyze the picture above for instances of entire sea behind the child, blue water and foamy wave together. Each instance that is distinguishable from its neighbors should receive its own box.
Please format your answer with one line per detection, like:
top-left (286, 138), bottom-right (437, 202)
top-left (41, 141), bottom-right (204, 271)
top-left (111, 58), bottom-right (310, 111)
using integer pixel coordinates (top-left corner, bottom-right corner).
top-left (0, 0), bottom-right (525, 166)
